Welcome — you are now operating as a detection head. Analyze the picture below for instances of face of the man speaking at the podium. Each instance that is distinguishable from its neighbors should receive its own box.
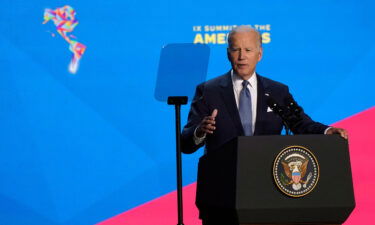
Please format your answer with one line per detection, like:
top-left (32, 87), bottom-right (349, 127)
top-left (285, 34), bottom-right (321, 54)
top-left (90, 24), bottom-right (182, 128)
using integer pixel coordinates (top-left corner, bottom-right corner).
top-left (227, 32), bottom-right (262, 80)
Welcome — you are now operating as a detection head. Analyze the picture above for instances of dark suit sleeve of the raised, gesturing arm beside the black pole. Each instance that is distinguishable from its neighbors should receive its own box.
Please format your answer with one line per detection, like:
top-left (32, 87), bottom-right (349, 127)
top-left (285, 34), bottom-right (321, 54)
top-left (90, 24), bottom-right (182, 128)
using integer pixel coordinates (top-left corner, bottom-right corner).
top-left (181, 84), bottom-right (209, 154)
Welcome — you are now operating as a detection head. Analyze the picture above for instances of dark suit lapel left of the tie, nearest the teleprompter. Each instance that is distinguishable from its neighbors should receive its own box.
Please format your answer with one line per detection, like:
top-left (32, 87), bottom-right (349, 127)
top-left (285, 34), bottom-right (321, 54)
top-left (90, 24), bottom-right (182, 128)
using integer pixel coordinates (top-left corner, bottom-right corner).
top-left (220, 72), bottom-right (244, 135)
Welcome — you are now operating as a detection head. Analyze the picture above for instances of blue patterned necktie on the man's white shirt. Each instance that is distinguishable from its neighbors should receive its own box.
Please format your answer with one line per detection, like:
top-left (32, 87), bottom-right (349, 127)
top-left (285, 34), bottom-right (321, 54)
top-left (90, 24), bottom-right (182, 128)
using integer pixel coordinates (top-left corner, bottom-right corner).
top-left (238, 80), bottom-right (253, 136)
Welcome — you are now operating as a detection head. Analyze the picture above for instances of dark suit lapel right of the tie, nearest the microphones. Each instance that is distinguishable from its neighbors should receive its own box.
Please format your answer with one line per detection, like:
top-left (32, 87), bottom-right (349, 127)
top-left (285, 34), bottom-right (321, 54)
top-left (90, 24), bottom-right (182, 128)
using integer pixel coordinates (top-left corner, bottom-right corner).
top-left (254, 74), bottom-right (268, 135)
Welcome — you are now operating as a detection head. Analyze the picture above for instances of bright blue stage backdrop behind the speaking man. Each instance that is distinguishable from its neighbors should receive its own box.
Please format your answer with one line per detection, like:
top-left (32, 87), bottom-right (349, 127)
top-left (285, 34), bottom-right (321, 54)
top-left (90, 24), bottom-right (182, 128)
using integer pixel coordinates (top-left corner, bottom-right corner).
top-left (0, 0), bottom-right (375, 225)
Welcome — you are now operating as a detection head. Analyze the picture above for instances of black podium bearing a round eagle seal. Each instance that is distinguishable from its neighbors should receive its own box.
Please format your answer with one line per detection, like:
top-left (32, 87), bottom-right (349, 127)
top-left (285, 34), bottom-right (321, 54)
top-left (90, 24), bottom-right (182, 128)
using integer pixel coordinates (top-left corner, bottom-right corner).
top-left (196, 135), bottom-right (355, 224)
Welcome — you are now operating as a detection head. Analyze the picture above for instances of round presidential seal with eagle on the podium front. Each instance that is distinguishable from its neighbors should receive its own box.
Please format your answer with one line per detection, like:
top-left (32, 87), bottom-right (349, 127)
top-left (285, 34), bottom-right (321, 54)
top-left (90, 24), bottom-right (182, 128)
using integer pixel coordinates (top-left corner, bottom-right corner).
top-left (273, 146), bottom-right (319, 197)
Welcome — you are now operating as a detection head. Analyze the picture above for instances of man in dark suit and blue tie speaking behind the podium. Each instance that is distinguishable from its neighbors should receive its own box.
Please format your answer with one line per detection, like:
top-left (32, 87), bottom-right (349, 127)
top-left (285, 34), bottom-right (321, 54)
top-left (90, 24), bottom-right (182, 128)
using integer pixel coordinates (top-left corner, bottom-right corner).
top-left (181, 26), bottom-right (348, 225)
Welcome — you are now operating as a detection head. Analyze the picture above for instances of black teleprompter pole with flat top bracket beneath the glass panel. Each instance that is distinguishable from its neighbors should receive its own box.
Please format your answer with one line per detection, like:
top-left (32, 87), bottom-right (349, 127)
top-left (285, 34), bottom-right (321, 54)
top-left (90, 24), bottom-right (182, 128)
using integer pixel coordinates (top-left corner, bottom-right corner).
top-left (168, 96), bottom-right (187, 225)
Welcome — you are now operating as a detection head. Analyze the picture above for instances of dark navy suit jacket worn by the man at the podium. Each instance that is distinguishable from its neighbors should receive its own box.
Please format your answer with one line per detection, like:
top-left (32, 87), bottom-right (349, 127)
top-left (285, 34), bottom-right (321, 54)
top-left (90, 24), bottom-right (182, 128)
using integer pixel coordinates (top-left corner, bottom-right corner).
top-left (181, 72), bottom-right (328, 153)
